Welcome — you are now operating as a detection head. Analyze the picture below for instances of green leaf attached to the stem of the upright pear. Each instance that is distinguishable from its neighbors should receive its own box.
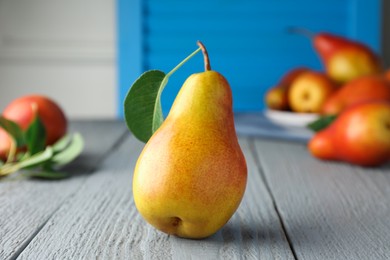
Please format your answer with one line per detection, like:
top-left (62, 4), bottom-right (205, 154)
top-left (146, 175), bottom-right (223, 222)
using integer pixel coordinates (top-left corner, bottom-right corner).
top-left (124, 70), bottom-right (168, 143)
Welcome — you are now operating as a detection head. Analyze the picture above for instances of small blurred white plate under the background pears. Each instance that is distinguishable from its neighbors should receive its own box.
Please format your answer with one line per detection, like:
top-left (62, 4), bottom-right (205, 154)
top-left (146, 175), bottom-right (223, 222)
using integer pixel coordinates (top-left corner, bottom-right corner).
top-left (264, 109), bottom-right (319, 127)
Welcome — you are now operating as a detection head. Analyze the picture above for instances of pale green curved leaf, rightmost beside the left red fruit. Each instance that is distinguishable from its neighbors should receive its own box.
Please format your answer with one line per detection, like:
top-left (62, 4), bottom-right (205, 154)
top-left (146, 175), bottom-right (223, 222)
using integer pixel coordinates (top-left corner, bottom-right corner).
top-left (50, 133), bottom-right (84, 166)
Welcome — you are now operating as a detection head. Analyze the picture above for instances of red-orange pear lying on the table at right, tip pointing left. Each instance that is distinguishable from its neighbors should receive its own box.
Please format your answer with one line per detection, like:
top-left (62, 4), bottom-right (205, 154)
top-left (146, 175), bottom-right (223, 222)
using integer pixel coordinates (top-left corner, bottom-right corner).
top-left (308, 101), bottom-right (390, 166)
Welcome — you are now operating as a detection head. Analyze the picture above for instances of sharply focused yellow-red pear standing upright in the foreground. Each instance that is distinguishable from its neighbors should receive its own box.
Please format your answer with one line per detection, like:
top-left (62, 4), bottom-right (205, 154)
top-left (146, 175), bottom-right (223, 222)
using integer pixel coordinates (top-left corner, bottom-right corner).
top-left (133, 43), bottom-right (247, 239)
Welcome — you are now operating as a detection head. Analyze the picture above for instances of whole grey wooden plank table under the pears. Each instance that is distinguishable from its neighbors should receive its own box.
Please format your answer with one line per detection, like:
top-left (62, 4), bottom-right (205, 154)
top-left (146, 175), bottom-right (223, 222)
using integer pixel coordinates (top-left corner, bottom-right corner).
top-left (0, 116), bottom-right (390, 260)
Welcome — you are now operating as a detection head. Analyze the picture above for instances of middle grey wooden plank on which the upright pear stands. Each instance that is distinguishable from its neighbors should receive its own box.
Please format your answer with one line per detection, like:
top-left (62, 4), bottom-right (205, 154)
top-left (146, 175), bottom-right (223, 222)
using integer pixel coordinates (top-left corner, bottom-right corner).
top-left (16, 137), bottom-right (293, 259)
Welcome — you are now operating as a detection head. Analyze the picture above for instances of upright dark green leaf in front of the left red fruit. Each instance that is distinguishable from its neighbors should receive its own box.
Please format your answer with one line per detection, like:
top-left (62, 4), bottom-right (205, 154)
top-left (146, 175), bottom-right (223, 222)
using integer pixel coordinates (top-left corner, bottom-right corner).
top-left (26, 115), bottom-right (46, 155)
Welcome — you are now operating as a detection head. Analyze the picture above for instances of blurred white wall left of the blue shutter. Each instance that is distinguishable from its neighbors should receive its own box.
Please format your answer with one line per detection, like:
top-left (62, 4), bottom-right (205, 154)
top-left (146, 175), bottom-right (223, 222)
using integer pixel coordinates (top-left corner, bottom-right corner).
top-left (0, 0), bottom-right (117, 118)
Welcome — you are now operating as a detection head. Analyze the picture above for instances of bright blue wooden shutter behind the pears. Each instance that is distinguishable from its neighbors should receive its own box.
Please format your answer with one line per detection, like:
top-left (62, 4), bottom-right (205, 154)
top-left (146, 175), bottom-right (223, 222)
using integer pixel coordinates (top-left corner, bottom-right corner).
top-left (118, 0), bottom-right (381, 115)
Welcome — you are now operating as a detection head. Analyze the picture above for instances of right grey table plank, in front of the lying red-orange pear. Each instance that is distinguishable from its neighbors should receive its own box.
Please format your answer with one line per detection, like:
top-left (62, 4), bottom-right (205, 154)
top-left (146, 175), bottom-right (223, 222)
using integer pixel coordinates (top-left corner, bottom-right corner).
top-left (255, 139), bottom-right (390, 259)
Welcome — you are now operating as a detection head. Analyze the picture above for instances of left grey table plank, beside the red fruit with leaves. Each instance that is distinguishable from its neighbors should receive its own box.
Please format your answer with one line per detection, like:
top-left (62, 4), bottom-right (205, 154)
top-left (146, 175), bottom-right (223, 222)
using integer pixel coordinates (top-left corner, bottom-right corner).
top-left (0, 121), bottom-right (126, 259)
